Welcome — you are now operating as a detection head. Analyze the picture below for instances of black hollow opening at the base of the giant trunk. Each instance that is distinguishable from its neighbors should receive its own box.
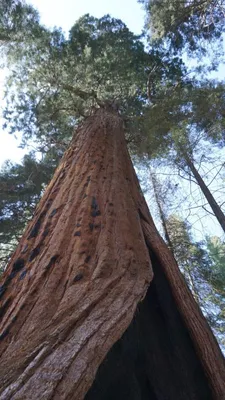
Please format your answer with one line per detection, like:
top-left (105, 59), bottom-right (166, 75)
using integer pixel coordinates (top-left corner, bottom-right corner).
top-left (85, 256), bottom-right (212, 400)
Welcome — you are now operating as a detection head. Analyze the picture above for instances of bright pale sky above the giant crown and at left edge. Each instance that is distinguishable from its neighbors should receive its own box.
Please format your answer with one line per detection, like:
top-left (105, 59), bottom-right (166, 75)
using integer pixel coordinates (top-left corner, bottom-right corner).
top-left (0, 0), bottom-right (144, 167)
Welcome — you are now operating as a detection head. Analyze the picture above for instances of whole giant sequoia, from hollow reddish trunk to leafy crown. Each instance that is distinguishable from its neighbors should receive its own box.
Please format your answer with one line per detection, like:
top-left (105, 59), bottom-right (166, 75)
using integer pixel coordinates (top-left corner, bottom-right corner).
top-left (0, 1), bottom-right (225, 400)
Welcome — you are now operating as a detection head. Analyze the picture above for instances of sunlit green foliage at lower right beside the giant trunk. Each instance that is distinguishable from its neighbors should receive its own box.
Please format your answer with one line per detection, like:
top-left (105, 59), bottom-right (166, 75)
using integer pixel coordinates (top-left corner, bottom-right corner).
top-left (166, 215), bottom-right (225, 347)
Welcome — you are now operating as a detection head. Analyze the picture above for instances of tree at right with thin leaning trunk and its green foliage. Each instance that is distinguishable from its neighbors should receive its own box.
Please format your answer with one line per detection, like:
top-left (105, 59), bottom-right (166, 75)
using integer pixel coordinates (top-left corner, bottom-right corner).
top-left (143, 78), bottom-right (225, 231)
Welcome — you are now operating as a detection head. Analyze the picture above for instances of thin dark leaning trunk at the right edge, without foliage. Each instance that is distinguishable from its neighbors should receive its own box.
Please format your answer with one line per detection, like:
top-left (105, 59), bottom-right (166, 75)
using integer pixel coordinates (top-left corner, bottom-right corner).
top-left (184, 154), bottom-right (225, 232)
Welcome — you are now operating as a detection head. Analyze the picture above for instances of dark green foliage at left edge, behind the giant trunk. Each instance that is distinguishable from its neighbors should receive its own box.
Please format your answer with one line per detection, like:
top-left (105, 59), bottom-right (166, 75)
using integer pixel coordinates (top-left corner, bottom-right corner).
top-left (0, 152), bottom-right (59, 269)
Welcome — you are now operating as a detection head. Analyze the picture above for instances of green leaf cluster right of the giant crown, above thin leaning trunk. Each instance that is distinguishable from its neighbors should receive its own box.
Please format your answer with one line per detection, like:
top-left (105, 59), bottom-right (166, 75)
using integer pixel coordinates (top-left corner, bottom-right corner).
top-left (140, 79), bottom-right (225, 157)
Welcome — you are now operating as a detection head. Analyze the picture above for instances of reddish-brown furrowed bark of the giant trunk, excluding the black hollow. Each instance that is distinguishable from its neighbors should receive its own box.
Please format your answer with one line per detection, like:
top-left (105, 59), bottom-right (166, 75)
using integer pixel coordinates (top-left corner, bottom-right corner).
top-left (0, 109), bottom-right (225, 400)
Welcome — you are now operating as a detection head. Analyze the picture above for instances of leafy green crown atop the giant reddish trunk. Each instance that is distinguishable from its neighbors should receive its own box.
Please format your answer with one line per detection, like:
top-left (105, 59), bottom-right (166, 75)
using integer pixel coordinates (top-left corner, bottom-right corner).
top-left (4, 15), bottom-right (148, 145)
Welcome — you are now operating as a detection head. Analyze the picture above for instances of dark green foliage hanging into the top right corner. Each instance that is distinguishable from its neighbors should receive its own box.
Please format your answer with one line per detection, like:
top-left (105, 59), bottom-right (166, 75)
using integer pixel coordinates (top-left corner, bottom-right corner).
top-left (139, 0), bottom-right (225, 54)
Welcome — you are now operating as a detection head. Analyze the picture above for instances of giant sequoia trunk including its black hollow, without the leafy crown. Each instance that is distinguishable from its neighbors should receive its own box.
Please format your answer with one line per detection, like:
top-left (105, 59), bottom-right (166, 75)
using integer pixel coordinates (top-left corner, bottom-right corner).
top-left (0, 109), bottom-right (225, 400)
